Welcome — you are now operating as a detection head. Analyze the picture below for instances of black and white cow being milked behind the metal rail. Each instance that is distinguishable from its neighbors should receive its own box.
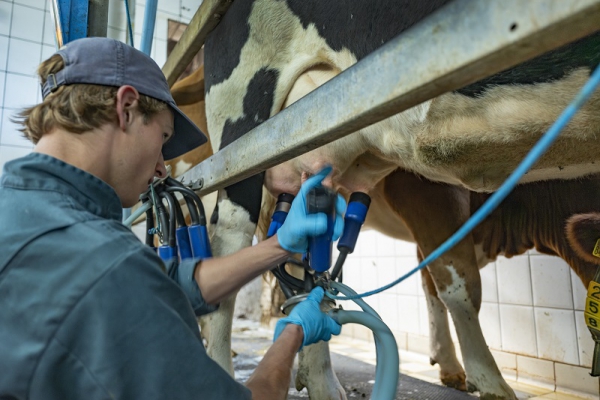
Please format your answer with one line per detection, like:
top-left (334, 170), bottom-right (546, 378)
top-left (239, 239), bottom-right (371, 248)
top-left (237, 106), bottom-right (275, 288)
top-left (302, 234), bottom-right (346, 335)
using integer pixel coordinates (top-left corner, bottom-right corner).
top-left (205, 0), bottom-right (600, 399)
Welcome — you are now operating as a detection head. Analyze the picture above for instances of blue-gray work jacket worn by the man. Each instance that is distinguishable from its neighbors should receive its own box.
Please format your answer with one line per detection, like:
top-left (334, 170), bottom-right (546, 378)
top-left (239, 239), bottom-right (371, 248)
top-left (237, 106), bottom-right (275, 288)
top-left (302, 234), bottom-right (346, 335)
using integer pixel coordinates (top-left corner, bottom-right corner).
top-left (0, 153), bottom-right (251, 400)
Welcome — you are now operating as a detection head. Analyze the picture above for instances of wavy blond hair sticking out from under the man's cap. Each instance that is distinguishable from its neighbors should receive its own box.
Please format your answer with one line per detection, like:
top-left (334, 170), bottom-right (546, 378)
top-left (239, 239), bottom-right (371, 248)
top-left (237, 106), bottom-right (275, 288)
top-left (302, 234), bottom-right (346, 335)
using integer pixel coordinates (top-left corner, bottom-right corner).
top-left (14, 54), bottom-right (168, 144)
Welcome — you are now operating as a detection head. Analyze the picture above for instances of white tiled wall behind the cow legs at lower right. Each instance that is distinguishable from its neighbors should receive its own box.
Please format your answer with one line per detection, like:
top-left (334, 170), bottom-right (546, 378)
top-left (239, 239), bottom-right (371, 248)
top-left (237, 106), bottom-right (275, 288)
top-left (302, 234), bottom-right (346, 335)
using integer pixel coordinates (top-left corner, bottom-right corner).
top-left (342, 231), bottom-right (598, 395)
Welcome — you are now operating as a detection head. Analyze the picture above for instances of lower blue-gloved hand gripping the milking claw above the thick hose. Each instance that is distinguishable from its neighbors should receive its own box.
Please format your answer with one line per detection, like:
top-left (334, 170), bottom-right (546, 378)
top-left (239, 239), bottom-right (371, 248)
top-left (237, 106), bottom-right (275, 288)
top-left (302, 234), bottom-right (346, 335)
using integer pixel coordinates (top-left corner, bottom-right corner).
top-left (273, 286), bottom-right (342, 349)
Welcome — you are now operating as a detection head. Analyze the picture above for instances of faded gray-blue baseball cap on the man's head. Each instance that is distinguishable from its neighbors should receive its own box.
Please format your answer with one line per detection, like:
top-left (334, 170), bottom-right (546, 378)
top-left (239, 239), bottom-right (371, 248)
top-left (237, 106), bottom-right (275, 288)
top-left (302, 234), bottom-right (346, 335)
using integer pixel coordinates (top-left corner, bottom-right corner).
top-left (42, 37), bottom-right (206, 160)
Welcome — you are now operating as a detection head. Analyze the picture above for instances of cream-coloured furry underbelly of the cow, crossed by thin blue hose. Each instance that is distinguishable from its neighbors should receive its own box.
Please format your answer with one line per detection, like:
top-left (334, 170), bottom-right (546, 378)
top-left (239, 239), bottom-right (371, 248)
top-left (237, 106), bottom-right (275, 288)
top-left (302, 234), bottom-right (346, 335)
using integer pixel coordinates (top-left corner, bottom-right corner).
top-left (408, 68), bottom-right (600, 191)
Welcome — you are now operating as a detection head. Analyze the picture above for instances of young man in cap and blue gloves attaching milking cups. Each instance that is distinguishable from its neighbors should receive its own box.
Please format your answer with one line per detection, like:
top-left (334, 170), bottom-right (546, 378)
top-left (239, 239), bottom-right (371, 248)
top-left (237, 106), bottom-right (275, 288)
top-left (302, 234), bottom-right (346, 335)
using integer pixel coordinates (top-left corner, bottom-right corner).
top-left (0, 38), bottom-right (344, 400)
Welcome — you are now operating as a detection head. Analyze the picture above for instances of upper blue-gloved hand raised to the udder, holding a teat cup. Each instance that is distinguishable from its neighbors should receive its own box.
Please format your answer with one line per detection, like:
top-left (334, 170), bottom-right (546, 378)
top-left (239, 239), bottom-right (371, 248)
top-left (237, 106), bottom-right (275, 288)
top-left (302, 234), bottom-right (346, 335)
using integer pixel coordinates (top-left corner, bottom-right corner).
top-left (277, 167), bottom-right (346, 253)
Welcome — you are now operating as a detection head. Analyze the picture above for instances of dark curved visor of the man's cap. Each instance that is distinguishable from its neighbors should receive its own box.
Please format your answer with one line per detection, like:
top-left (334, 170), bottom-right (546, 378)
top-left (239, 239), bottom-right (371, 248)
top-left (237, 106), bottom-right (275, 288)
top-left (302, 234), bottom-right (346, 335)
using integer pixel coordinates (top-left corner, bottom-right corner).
top-left (162, 105), bottom-right (207, 160)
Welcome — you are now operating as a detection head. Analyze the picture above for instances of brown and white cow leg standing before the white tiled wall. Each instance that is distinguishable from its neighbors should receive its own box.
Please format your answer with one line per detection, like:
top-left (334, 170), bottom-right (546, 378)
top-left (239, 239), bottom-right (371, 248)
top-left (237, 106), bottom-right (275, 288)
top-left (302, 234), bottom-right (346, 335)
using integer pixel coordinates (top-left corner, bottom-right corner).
top-left (385, 170), bottom-right (515, 399)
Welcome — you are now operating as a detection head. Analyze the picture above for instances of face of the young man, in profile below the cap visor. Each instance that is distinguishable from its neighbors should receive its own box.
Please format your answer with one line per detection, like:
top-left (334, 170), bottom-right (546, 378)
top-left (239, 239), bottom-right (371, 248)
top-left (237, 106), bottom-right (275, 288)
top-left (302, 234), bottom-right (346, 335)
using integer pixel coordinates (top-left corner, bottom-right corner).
top-left (120, 110), bottom-right (173, 207)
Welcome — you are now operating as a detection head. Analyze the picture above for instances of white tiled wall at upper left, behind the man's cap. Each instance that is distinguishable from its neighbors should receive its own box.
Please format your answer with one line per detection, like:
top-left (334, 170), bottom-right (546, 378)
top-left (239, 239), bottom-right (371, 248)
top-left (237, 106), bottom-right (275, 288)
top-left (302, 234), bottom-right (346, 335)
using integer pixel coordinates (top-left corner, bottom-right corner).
top-left (0, 0), bottom-right (202, 173)
